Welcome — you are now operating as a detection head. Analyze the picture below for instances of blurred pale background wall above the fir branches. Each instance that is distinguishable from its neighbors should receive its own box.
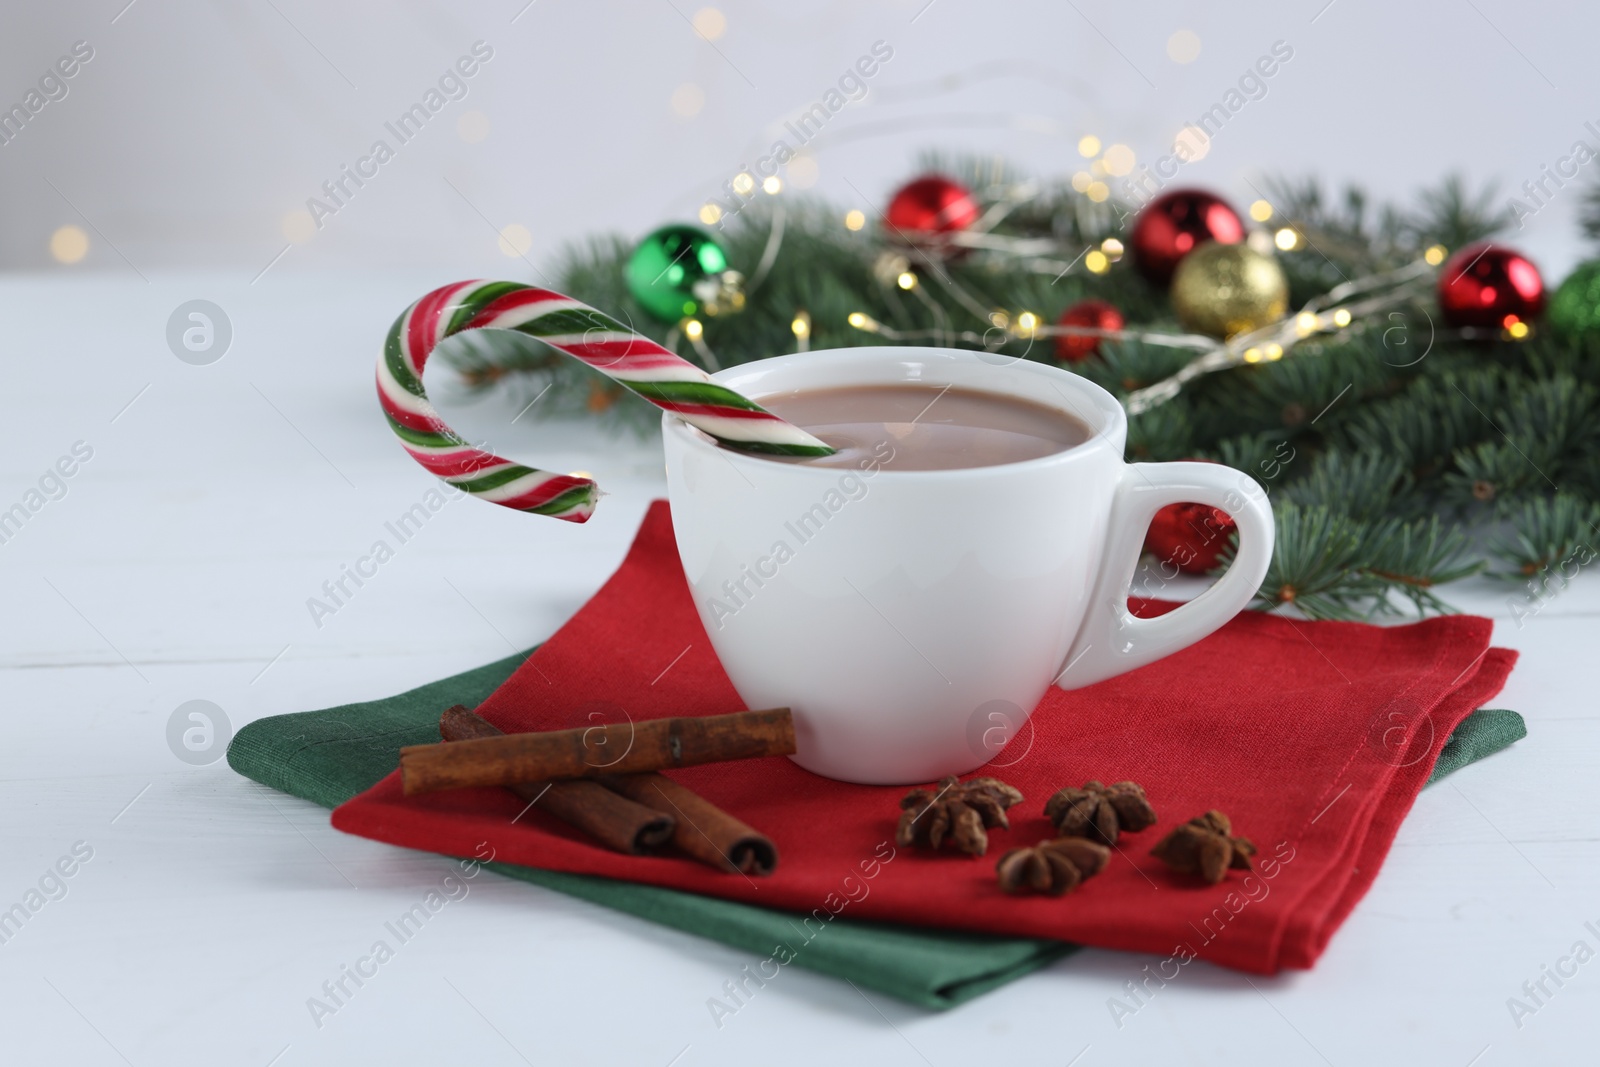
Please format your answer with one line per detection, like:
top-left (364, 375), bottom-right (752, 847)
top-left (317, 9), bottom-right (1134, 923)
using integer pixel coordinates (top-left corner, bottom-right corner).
top-left (0, 0), bottom-right (1600, 285)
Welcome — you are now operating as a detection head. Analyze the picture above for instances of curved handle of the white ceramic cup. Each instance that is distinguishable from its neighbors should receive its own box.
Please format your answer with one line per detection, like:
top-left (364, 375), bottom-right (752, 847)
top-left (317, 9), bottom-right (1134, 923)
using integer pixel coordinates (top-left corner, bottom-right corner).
top-left (1056, 462), bottom-right (1274, 689)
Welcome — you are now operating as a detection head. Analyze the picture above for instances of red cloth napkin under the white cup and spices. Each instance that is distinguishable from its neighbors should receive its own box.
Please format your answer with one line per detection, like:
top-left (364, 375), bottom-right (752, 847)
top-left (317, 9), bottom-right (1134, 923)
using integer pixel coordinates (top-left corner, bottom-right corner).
top-left (333, 502), bottom-right (1515, 976)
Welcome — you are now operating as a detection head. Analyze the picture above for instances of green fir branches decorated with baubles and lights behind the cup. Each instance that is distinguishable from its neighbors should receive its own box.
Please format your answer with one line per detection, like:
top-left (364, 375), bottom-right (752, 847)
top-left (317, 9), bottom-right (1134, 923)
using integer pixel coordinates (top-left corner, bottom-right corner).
top-left (425, 163), bottom-right (1600, 619)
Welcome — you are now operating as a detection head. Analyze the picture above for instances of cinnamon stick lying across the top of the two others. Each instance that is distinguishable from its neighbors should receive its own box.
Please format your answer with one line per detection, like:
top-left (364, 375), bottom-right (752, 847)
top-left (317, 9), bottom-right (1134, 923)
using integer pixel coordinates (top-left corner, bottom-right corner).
top-left (400, 707), bottom-right (795, 797)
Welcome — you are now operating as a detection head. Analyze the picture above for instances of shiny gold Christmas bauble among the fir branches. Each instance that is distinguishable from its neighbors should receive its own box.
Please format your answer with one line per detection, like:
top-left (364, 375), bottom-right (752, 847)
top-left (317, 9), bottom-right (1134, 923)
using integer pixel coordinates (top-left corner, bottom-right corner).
top-left (1173, 242), bottom-right (1290, 338)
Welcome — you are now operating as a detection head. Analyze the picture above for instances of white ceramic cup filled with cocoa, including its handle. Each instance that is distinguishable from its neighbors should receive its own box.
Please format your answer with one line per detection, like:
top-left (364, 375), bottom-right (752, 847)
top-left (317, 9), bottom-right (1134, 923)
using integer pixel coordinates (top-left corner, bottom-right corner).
top-left (662, 347), bottom-right (1274, 784)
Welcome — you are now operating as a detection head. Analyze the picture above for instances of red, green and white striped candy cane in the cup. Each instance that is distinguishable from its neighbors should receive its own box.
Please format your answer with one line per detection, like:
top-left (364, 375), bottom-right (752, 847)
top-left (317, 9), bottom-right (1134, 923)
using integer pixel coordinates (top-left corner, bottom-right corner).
top-left (378, 282), bottom-right (834, 523)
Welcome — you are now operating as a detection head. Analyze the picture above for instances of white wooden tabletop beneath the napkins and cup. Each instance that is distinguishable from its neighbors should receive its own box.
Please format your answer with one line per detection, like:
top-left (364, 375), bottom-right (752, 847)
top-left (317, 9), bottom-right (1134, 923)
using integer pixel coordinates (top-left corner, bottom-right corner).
top-left (0, 274), bottom-right (1600, 1067)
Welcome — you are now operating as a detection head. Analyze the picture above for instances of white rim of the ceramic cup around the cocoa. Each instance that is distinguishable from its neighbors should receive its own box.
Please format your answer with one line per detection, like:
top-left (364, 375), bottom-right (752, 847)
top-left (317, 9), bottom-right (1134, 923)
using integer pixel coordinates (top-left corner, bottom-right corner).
top-left (661, 346), bottom-right (1128, 482)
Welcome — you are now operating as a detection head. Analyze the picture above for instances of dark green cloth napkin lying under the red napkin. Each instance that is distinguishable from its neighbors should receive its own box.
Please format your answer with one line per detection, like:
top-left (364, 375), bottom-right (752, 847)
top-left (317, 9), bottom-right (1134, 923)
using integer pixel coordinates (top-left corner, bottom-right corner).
top-left (227, 653), bottom-right (1526, 1009)
